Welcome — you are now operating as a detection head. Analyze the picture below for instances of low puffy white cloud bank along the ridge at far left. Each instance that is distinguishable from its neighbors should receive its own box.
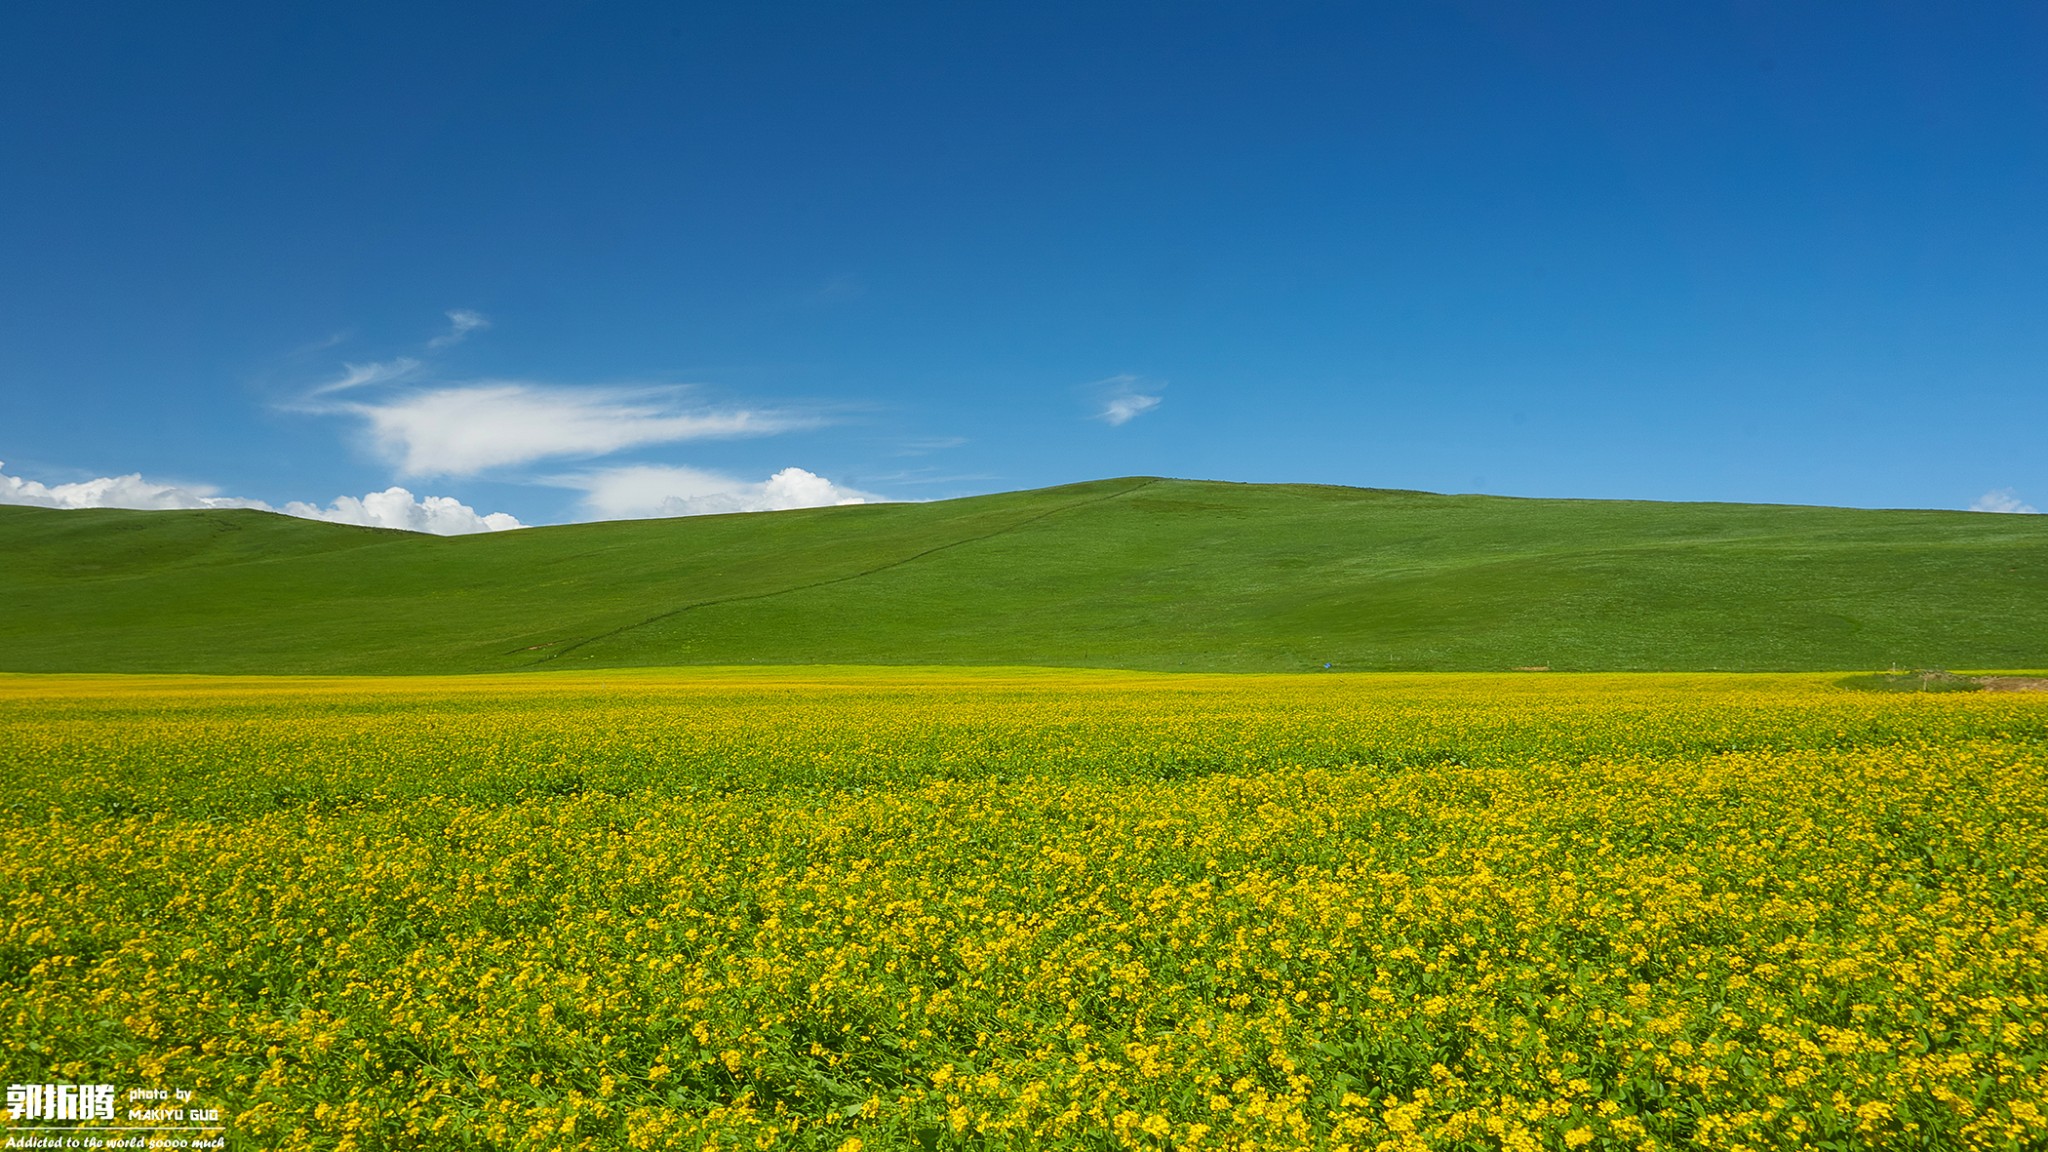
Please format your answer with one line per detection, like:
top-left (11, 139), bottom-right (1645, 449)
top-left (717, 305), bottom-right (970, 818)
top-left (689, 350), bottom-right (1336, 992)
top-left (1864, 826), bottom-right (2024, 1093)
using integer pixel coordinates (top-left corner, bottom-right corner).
top-left (0, 461), bottom-right (522, 535)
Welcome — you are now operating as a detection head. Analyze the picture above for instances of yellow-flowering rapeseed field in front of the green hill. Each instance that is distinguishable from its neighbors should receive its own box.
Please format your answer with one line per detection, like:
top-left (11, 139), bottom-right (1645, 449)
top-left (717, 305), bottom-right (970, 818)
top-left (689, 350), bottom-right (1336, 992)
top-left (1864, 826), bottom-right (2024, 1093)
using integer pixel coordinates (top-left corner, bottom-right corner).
top-left (0, 670), bottom-right (2048, 1152)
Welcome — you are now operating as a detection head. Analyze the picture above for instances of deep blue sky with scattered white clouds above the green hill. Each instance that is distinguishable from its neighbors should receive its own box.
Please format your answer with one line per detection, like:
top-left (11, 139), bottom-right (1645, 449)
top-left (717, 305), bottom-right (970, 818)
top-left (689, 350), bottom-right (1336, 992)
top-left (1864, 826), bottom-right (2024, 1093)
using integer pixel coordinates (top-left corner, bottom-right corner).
top-left (0, 2), bottom-right (2048, 531)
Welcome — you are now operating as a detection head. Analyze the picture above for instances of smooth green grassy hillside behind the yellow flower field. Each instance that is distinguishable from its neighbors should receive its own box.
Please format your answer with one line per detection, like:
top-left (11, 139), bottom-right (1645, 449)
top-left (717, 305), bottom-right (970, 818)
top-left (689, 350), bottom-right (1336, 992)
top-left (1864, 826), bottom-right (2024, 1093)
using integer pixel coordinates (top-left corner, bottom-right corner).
top-left (0, 478), bottom-right (2048, 672)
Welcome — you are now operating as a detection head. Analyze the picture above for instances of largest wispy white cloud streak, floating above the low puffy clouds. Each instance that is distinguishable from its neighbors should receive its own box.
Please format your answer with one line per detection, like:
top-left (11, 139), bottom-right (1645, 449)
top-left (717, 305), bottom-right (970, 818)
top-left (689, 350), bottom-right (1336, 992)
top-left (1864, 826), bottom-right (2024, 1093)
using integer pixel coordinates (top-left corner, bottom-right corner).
top-left (342, 381), bottom-right (815, 476)
